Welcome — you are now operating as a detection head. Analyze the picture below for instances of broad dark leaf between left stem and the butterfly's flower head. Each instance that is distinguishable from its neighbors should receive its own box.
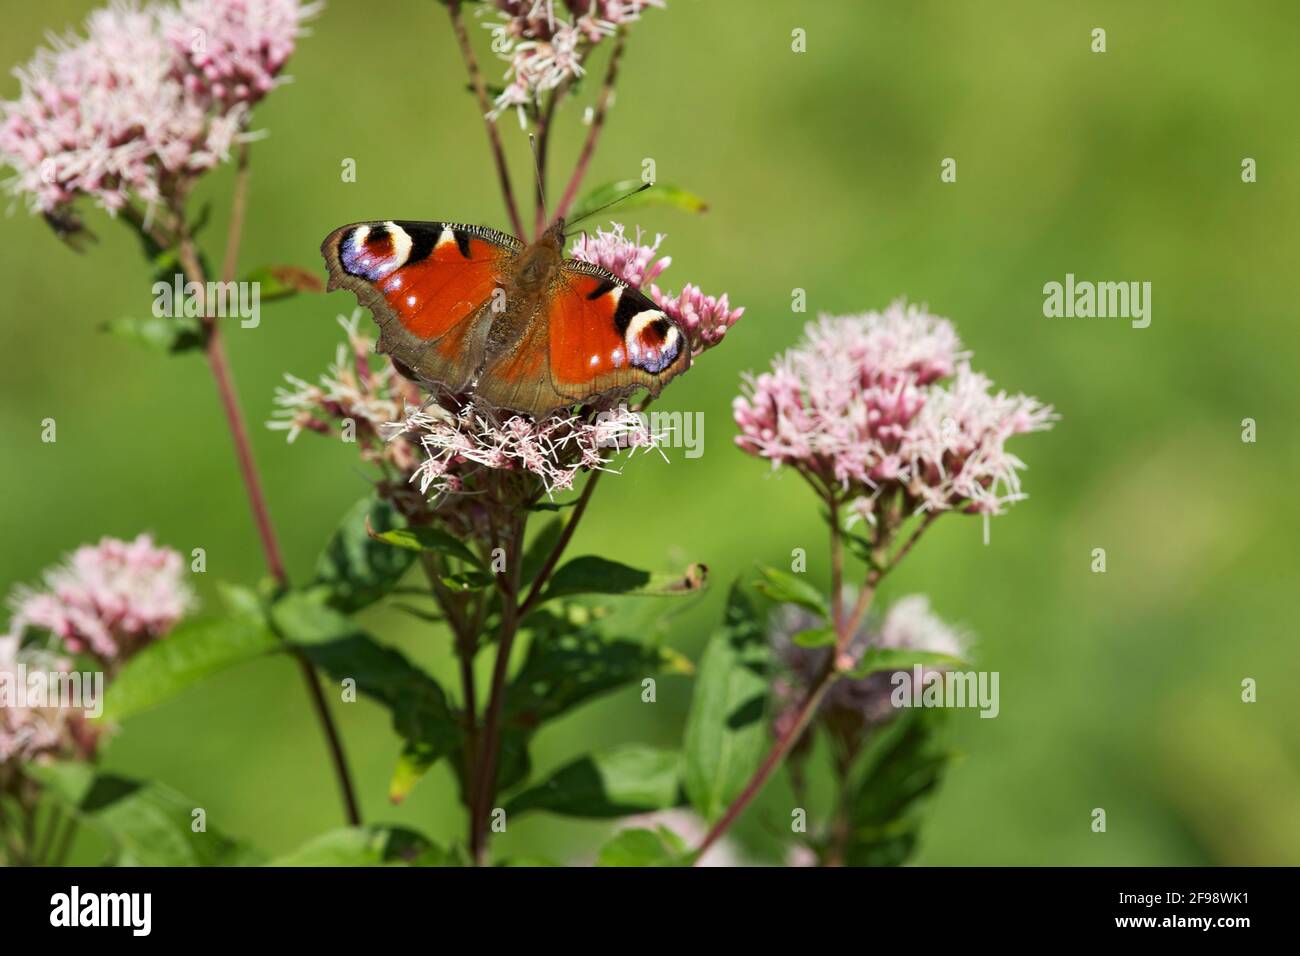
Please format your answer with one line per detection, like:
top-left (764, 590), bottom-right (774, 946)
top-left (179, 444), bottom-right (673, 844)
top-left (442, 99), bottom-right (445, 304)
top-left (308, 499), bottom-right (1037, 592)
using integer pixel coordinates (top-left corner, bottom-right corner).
top-left (313, 494), bottom-right (415, 613)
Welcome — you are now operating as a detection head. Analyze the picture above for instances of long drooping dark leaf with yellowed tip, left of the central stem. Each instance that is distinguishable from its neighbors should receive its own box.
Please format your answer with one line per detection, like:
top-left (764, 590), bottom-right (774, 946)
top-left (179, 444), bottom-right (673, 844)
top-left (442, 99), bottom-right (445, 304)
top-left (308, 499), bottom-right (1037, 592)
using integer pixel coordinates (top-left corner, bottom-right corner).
top-left (272, 593), bottom-right (462, 801)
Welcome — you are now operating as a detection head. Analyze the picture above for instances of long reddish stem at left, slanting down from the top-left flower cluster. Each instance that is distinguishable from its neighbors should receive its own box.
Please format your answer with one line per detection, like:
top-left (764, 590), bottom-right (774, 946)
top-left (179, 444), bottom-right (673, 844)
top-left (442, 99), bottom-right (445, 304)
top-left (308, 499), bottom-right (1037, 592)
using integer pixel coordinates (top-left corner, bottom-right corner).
top-left (176, 209), bottom-right (361, 826)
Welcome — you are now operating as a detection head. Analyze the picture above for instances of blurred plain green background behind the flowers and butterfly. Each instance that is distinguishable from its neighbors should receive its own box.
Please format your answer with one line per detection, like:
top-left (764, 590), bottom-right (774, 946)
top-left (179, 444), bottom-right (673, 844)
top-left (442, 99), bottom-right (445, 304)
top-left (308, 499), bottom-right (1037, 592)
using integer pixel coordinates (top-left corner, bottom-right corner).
top-left (0, 0), bottom-right (1300, 865)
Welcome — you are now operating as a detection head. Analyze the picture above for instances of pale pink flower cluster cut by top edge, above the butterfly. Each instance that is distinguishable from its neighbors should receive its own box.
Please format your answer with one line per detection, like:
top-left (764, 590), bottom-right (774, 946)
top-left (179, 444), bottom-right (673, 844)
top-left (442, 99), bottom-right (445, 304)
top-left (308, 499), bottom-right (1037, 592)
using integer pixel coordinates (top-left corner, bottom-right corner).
top-left (488, 0), bottom-right (663, 118)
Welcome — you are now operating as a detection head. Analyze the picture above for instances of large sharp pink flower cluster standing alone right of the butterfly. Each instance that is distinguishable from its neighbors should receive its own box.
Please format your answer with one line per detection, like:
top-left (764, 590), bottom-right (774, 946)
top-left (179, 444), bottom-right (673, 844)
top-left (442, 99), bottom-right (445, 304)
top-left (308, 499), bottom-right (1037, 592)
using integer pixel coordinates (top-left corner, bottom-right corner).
top-left (733, 302), bottom-right (1057, 520)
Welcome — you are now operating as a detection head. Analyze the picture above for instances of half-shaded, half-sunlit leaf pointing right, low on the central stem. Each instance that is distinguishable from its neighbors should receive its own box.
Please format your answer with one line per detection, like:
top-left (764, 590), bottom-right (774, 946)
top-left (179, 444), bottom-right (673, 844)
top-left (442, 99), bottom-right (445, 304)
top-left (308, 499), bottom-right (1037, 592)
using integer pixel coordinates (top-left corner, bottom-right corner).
top-left (506, 745), bottom-right (681, 817)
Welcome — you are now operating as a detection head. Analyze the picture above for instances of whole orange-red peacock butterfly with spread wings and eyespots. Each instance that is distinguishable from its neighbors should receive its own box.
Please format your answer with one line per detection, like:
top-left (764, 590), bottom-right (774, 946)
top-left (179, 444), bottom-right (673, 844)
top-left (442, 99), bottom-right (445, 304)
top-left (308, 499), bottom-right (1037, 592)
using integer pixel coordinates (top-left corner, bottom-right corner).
top-left (321, 220), bottom-right (690, 418)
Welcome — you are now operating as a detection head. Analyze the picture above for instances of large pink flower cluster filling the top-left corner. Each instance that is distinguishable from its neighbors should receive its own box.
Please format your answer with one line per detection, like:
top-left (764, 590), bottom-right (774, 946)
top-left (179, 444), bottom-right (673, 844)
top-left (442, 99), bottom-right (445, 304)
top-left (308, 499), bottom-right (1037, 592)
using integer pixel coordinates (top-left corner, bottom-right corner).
top-left (0, 0), bottom-right (315, 213)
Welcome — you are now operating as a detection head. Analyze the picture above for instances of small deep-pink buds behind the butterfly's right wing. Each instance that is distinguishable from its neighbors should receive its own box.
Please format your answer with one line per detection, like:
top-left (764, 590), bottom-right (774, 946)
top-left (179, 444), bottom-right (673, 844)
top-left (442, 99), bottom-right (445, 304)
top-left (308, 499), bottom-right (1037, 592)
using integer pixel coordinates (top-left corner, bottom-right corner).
top-left (569, 222), bottom-right (745, 356)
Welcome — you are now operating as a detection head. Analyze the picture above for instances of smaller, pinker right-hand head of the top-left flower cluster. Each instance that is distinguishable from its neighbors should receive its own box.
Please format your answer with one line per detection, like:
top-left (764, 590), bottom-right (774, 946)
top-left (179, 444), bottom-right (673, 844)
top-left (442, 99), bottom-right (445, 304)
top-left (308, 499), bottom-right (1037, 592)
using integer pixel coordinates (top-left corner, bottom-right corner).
top-left (161, 0), bottom-right (322, 109)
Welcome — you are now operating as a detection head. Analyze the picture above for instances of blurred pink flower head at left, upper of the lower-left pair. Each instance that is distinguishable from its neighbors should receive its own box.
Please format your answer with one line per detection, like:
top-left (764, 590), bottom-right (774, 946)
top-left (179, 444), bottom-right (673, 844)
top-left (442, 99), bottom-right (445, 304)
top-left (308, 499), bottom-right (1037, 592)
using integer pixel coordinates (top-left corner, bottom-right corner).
top-left (10, 535), bottom-right (194, 666)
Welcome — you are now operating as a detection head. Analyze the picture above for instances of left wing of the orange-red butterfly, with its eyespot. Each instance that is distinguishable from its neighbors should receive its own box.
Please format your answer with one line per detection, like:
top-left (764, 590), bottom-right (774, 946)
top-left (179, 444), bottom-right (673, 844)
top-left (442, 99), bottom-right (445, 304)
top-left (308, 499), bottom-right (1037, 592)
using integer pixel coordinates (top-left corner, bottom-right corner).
top-left (321, 220), bottom-right (521, 392)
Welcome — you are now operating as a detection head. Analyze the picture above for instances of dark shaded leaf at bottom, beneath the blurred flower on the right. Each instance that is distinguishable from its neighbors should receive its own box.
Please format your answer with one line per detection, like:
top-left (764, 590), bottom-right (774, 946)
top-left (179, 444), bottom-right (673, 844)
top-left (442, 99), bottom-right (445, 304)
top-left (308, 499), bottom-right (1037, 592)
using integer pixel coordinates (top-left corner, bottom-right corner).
top-left (845, 710), bottom-right (954, 866)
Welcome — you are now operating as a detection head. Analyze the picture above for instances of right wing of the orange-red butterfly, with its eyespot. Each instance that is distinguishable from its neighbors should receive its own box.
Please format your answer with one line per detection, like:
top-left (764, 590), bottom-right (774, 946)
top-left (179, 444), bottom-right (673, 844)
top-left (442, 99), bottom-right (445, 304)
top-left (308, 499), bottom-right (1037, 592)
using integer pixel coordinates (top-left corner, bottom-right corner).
top-left (476, 259), bottom-right (690, 416)
